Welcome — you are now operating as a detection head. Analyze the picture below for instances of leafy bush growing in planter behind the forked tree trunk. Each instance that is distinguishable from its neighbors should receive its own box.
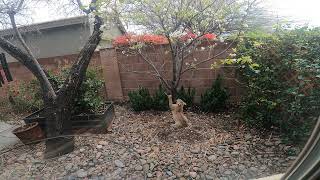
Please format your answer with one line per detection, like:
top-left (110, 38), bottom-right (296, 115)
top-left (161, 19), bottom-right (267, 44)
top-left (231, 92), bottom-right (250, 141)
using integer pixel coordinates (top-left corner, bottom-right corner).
top-left (9, 68), bottom-right (104, 114)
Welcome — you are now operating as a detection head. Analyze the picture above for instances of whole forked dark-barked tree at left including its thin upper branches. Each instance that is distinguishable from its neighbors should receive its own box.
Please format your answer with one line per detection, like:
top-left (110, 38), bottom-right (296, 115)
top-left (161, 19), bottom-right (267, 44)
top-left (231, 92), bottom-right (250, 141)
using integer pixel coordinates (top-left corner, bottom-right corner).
top-left (0, 0), bottom-right (102, 158)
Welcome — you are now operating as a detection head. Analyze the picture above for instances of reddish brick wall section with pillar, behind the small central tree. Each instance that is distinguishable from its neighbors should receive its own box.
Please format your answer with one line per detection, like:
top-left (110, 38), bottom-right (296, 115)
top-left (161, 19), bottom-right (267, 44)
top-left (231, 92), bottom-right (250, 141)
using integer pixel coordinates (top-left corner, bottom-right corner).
top-left (100, 44), bottom-right (242, 101)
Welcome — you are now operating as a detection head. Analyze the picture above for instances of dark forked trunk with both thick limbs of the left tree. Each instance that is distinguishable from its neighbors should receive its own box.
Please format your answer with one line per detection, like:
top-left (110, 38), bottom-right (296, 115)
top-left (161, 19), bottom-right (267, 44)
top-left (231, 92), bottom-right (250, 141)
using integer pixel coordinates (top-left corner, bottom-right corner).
top-left (0, 18), bottom-right (102, 158)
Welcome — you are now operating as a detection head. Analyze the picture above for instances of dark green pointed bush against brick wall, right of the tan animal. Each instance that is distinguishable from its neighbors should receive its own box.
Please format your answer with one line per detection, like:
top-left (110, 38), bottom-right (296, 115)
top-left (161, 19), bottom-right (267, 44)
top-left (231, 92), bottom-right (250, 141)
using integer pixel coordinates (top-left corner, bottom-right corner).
top-left (200, 75), bottom-right (229, 112)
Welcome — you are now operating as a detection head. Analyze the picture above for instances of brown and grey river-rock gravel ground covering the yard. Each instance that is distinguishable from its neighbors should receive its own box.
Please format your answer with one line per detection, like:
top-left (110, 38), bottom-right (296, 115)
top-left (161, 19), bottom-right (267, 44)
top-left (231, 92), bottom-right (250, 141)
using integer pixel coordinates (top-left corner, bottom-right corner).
top-left (0, 106), bottom-right (299, 180)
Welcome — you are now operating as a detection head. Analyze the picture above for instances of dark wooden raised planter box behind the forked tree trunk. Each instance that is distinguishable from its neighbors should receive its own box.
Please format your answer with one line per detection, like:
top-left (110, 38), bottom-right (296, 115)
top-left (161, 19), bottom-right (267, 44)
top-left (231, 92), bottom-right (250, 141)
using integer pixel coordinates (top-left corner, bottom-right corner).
top-left (23, 102), bottom-right (115, 134)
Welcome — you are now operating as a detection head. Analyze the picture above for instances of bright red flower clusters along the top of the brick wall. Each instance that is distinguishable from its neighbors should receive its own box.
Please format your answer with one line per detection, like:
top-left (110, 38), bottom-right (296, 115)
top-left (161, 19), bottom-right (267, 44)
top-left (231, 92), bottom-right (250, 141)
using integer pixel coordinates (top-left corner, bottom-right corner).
top-left (112, 32), bottom-right (217, 46)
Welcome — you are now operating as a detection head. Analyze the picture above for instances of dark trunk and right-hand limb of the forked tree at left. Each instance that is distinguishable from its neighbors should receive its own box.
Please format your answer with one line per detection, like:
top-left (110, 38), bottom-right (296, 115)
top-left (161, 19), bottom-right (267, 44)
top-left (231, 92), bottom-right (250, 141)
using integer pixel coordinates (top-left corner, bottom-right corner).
top-left (45, 25), bottom-right (102, 158)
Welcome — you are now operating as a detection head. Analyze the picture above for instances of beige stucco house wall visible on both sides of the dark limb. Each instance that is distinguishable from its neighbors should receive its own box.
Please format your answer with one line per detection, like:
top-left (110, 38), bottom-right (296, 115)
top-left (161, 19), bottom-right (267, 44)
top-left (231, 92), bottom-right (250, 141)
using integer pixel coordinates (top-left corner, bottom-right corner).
top-left (0, 16), bottom-right (121, 62)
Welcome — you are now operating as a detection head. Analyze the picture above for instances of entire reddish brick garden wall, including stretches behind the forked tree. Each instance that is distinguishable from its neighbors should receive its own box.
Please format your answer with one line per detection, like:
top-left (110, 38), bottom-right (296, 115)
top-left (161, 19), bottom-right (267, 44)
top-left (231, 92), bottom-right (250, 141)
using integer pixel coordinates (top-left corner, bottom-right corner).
top-left (0, 44), bottom-right (242, 101)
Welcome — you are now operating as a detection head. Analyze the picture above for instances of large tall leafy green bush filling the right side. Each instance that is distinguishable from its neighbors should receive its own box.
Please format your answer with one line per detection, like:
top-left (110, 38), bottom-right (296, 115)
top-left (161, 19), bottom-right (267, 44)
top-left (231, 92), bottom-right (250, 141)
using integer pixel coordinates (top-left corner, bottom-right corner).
top-left (224, 28), bottom-right (320, 141)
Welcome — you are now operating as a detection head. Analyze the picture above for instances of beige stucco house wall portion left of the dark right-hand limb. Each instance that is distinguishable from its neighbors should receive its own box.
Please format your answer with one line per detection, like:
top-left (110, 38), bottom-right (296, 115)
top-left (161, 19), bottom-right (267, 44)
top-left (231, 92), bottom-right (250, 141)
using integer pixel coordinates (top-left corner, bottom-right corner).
top-left (0, 24), bottom-right (90, 62)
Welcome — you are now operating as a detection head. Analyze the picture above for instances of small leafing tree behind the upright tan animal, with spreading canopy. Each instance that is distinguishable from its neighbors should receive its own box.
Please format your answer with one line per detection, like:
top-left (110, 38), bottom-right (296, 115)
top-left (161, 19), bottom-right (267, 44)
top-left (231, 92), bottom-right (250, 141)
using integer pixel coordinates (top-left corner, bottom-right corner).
top-left (112, 0), bottom-right (257, 100)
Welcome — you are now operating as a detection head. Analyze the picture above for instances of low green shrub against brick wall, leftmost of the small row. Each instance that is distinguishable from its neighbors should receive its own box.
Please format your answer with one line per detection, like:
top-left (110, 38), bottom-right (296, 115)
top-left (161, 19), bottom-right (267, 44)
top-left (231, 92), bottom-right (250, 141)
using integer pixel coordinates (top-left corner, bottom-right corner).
top-left (128, 87), bottom-right (153, 111)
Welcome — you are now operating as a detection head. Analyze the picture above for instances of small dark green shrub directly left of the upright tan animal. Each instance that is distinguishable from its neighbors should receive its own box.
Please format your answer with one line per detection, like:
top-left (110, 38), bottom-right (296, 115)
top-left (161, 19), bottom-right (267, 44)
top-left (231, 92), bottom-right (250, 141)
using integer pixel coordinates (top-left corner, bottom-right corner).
top-left (152, 85), bottom-right (169, 111)
